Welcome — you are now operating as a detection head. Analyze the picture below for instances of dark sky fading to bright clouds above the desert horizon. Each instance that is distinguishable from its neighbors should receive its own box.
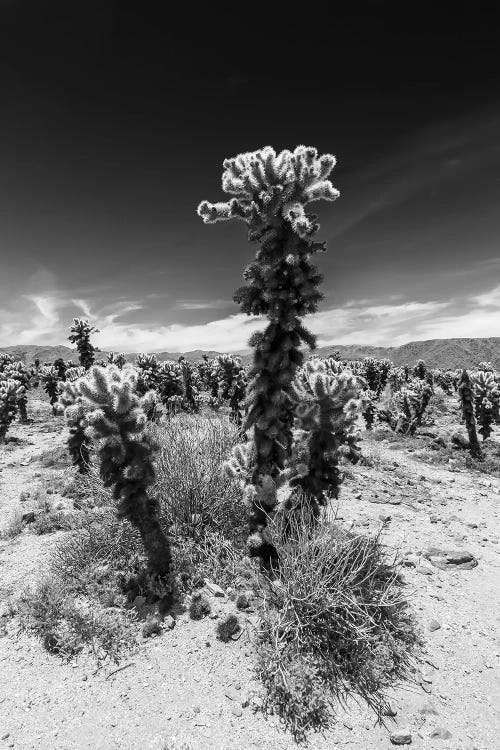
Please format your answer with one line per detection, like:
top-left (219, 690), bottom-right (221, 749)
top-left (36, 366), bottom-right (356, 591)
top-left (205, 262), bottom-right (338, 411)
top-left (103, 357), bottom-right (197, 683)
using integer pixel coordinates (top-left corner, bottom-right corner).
top-left (0, 0), bottom-right (500, 350)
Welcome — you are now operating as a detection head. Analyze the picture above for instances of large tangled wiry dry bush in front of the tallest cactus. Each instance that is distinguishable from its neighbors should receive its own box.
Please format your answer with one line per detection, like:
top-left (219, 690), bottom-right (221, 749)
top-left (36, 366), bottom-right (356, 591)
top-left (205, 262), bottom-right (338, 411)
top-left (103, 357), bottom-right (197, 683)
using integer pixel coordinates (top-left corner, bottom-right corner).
top-left (257, 507), bottom-right (419, 742)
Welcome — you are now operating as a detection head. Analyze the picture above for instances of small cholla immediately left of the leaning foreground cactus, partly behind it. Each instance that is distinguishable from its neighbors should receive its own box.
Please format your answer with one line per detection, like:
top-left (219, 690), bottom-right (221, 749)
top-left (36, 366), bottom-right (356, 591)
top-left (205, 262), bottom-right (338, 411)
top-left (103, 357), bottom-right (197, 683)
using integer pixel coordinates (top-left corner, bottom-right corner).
top-left (57, 378), bottom-right (90, 474)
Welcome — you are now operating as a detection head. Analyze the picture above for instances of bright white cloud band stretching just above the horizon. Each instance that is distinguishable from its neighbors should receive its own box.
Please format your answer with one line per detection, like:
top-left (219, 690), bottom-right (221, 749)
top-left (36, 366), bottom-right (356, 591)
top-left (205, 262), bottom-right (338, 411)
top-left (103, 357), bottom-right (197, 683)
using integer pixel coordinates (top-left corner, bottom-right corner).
top-left (0, 284), bottom-right (500, 352)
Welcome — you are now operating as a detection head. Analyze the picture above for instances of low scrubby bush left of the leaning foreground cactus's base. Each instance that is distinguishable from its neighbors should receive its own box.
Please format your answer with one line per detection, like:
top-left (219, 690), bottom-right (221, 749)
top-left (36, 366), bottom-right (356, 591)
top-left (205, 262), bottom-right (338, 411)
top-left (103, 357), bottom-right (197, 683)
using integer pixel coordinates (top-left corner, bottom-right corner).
top-left (17, 511), bottom-right (147, 662)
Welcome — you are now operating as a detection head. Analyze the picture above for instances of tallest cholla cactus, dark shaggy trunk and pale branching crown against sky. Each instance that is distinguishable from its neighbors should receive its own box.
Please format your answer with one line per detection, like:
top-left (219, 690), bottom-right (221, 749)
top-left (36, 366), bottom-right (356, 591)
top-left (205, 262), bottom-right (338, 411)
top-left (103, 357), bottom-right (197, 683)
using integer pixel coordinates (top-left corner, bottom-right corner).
top-left (198, 146), bottom-right (338, 560)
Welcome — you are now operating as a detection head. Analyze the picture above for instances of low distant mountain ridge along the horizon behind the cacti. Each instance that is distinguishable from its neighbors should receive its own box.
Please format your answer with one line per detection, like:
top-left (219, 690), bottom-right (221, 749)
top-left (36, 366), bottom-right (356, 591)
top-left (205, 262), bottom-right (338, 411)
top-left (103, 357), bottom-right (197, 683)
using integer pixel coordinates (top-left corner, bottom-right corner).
top-left (0, 337), bottom-right (500, 370)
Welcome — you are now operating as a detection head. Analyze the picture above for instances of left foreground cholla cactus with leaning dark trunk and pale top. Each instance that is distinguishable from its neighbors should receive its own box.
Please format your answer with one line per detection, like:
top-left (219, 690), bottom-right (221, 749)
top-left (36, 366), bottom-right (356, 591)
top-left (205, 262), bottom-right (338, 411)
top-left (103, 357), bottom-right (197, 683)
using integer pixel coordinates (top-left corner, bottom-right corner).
top-left (78, 365), bottom-right (171, 582)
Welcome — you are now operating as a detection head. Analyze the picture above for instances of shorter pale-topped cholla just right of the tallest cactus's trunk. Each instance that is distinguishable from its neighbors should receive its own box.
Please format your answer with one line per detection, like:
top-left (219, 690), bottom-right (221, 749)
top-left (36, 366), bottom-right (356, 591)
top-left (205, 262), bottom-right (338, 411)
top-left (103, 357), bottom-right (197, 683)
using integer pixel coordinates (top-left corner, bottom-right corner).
top-left (290, 359), bottom-right (362, 512)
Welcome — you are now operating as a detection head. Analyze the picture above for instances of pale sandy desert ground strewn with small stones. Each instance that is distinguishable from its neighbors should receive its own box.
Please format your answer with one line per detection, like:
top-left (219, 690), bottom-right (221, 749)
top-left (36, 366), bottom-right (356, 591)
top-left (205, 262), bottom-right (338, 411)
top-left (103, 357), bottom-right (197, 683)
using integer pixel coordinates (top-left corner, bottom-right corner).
top-left (0, 399), bottom-right (500, 750)
